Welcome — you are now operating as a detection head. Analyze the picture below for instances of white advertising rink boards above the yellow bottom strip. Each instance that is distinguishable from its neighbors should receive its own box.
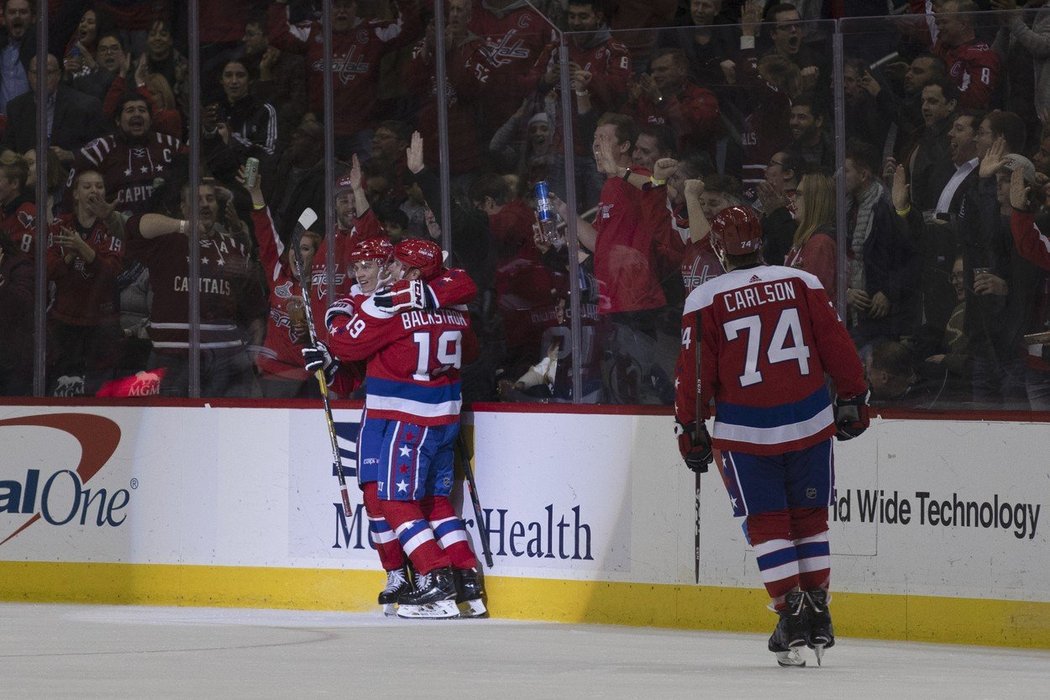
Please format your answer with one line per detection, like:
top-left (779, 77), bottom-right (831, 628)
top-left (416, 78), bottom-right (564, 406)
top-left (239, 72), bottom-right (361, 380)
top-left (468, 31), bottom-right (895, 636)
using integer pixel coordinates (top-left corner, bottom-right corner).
top-left (0, 406), bottom-right (1050, 601)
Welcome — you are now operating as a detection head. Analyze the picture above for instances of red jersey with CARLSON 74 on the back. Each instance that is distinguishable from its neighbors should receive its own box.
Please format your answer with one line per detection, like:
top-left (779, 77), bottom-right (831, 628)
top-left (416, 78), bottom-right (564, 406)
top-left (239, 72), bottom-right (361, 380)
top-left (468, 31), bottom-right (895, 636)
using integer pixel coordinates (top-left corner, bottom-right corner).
top-left (675, 266), bottom-right (867, 454)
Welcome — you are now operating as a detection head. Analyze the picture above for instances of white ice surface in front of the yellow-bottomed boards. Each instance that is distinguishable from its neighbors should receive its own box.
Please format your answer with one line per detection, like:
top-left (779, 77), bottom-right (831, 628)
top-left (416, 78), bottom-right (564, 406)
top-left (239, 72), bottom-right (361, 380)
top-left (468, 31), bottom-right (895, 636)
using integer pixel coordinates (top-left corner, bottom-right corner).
top-left (0, 603), bottom-right (1050, 700)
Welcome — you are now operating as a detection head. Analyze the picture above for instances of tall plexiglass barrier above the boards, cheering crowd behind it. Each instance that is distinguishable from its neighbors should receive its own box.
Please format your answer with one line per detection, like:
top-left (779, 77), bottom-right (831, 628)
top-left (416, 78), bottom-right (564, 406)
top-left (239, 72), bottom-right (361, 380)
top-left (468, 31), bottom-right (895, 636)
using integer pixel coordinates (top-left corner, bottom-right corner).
top-left (0, 0), bottom-right (1050, 410)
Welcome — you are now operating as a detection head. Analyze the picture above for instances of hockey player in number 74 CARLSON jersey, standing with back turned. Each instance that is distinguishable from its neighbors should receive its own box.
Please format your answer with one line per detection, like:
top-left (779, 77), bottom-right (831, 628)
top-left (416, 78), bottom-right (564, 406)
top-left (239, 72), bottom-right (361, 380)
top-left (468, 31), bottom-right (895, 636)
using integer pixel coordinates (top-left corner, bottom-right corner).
top-left (675, 207), bottom-right (868, 665)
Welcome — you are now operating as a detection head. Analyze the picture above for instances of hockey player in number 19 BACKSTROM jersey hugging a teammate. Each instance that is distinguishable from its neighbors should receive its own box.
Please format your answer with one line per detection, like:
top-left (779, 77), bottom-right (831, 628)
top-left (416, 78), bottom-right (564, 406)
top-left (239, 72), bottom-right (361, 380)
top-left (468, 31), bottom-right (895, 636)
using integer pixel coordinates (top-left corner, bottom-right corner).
top-left (303, 238), bottom-right (486, 617)
